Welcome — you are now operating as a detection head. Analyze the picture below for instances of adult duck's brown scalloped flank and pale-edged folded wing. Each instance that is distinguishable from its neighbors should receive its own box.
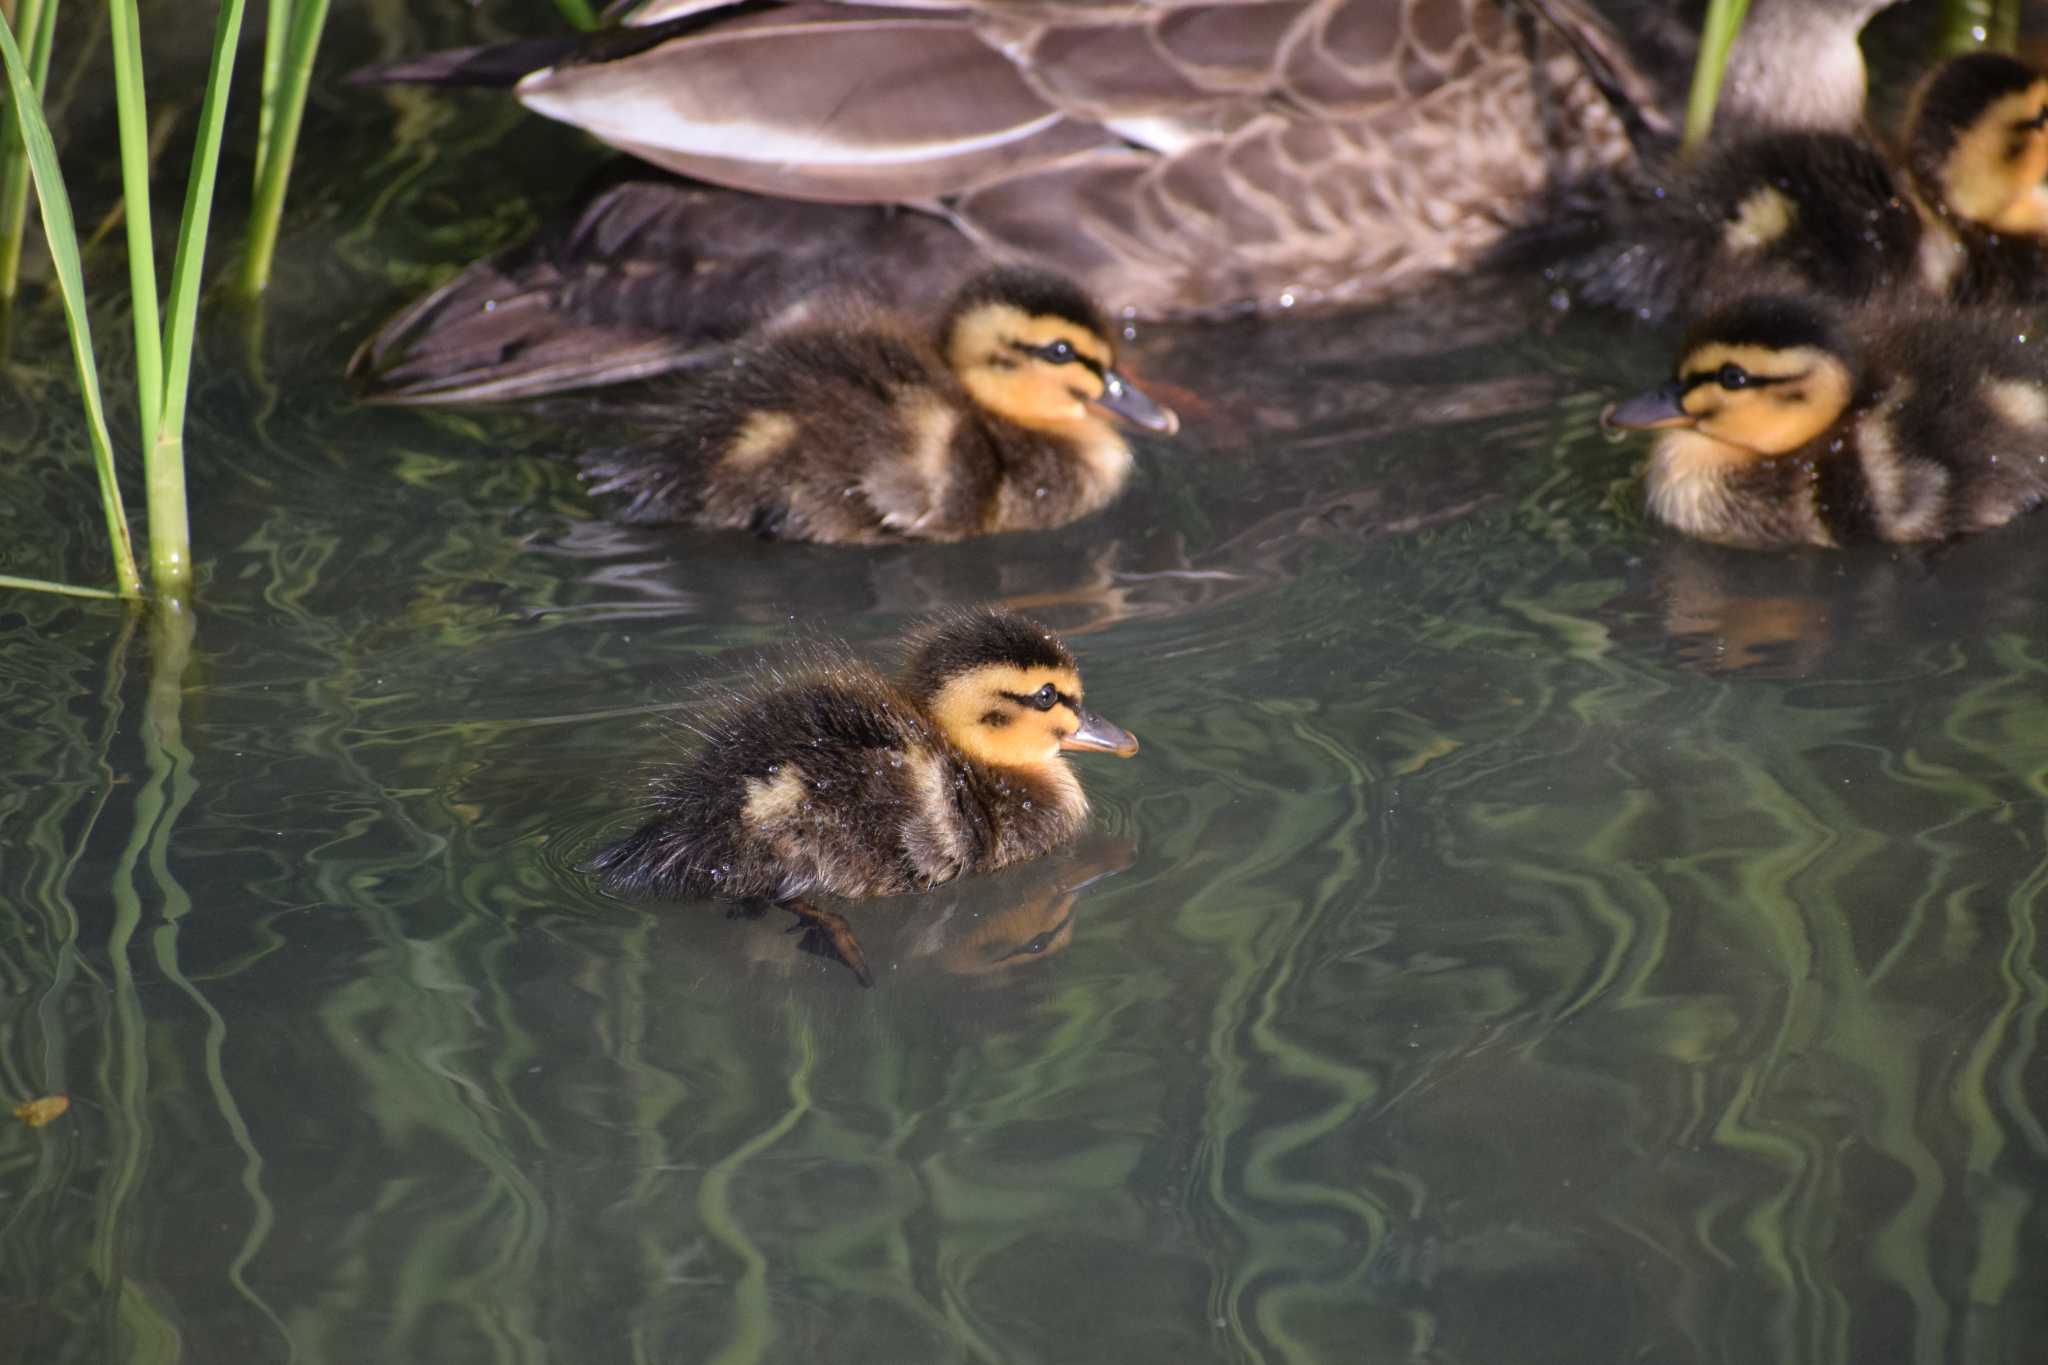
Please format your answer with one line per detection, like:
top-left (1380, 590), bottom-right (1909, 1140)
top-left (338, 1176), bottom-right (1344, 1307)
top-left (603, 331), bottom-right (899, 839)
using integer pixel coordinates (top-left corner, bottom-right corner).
top-left (518, 0), bottom-right (1659, 315)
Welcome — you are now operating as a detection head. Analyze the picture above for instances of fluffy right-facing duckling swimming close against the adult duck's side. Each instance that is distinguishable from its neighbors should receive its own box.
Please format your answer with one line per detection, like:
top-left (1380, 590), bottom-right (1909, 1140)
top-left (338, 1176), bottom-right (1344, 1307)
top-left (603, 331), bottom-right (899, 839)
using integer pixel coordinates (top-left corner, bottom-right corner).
top-left (586, 268), bottom-right (1180, 544)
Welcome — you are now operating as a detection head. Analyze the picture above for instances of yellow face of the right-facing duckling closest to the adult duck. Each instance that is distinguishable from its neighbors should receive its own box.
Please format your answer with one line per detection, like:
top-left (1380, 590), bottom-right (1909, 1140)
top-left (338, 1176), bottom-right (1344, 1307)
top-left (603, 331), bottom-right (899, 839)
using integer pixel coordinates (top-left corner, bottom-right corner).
top-left (946, 303), bottom-right (1116, 432)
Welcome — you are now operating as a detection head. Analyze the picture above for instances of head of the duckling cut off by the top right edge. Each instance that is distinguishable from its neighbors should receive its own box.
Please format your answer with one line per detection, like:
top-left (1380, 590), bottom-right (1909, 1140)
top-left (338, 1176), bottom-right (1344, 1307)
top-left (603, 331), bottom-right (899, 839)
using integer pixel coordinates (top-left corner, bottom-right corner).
top-left (1905, 51), bottom-right (2048, 303)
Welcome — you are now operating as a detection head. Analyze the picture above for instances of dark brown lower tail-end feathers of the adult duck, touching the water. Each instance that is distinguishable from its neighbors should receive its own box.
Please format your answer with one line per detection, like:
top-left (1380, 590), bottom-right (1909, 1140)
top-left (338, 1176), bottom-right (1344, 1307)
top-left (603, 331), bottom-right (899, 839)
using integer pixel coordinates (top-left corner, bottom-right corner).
top-left (350, 172), bottom-right (975, 403)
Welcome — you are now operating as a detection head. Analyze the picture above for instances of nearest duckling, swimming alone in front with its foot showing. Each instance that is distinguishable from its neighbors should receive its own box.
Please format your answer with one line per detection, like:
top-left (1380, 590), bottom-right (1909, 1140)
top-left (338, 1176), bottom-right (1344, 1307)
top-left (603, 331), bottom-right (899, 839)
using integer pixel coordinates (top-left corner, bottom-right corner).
top-left (590, 608), bottom-right (1139, 984)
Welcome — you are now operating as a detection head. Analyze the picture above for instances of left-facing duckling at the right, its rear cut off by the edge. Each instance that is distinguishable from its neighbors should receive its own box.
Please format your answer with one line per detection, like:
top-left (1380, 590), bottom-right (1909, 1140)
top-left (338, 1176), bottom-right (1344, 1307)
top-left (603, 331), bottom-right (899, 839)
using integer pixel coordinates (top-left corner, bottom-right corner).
top-left (1602, 297), bottom-right (2048, 548)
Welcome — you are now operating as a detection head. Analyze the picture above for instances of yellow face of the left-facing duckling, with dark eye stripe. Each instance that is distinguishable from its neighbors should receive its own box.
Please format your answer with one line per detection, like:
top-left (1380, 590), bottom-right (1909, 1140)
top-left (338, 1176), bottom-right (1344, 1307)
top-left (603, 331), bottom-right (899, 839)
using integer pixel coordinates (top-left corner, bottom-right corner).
top-left (1679, 342), bottom-right (1851, 463)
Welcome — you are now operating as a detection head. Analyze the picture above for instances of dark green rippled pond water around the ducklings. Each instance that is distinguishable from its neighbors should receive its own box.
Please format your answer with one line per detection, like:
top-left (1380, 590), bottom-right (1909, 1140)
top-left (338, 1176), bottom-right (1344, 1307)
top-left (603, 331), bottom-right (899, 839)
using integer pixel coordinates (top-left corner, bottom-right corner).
top-left (0, 0), bottom-right (2048, 1365)
